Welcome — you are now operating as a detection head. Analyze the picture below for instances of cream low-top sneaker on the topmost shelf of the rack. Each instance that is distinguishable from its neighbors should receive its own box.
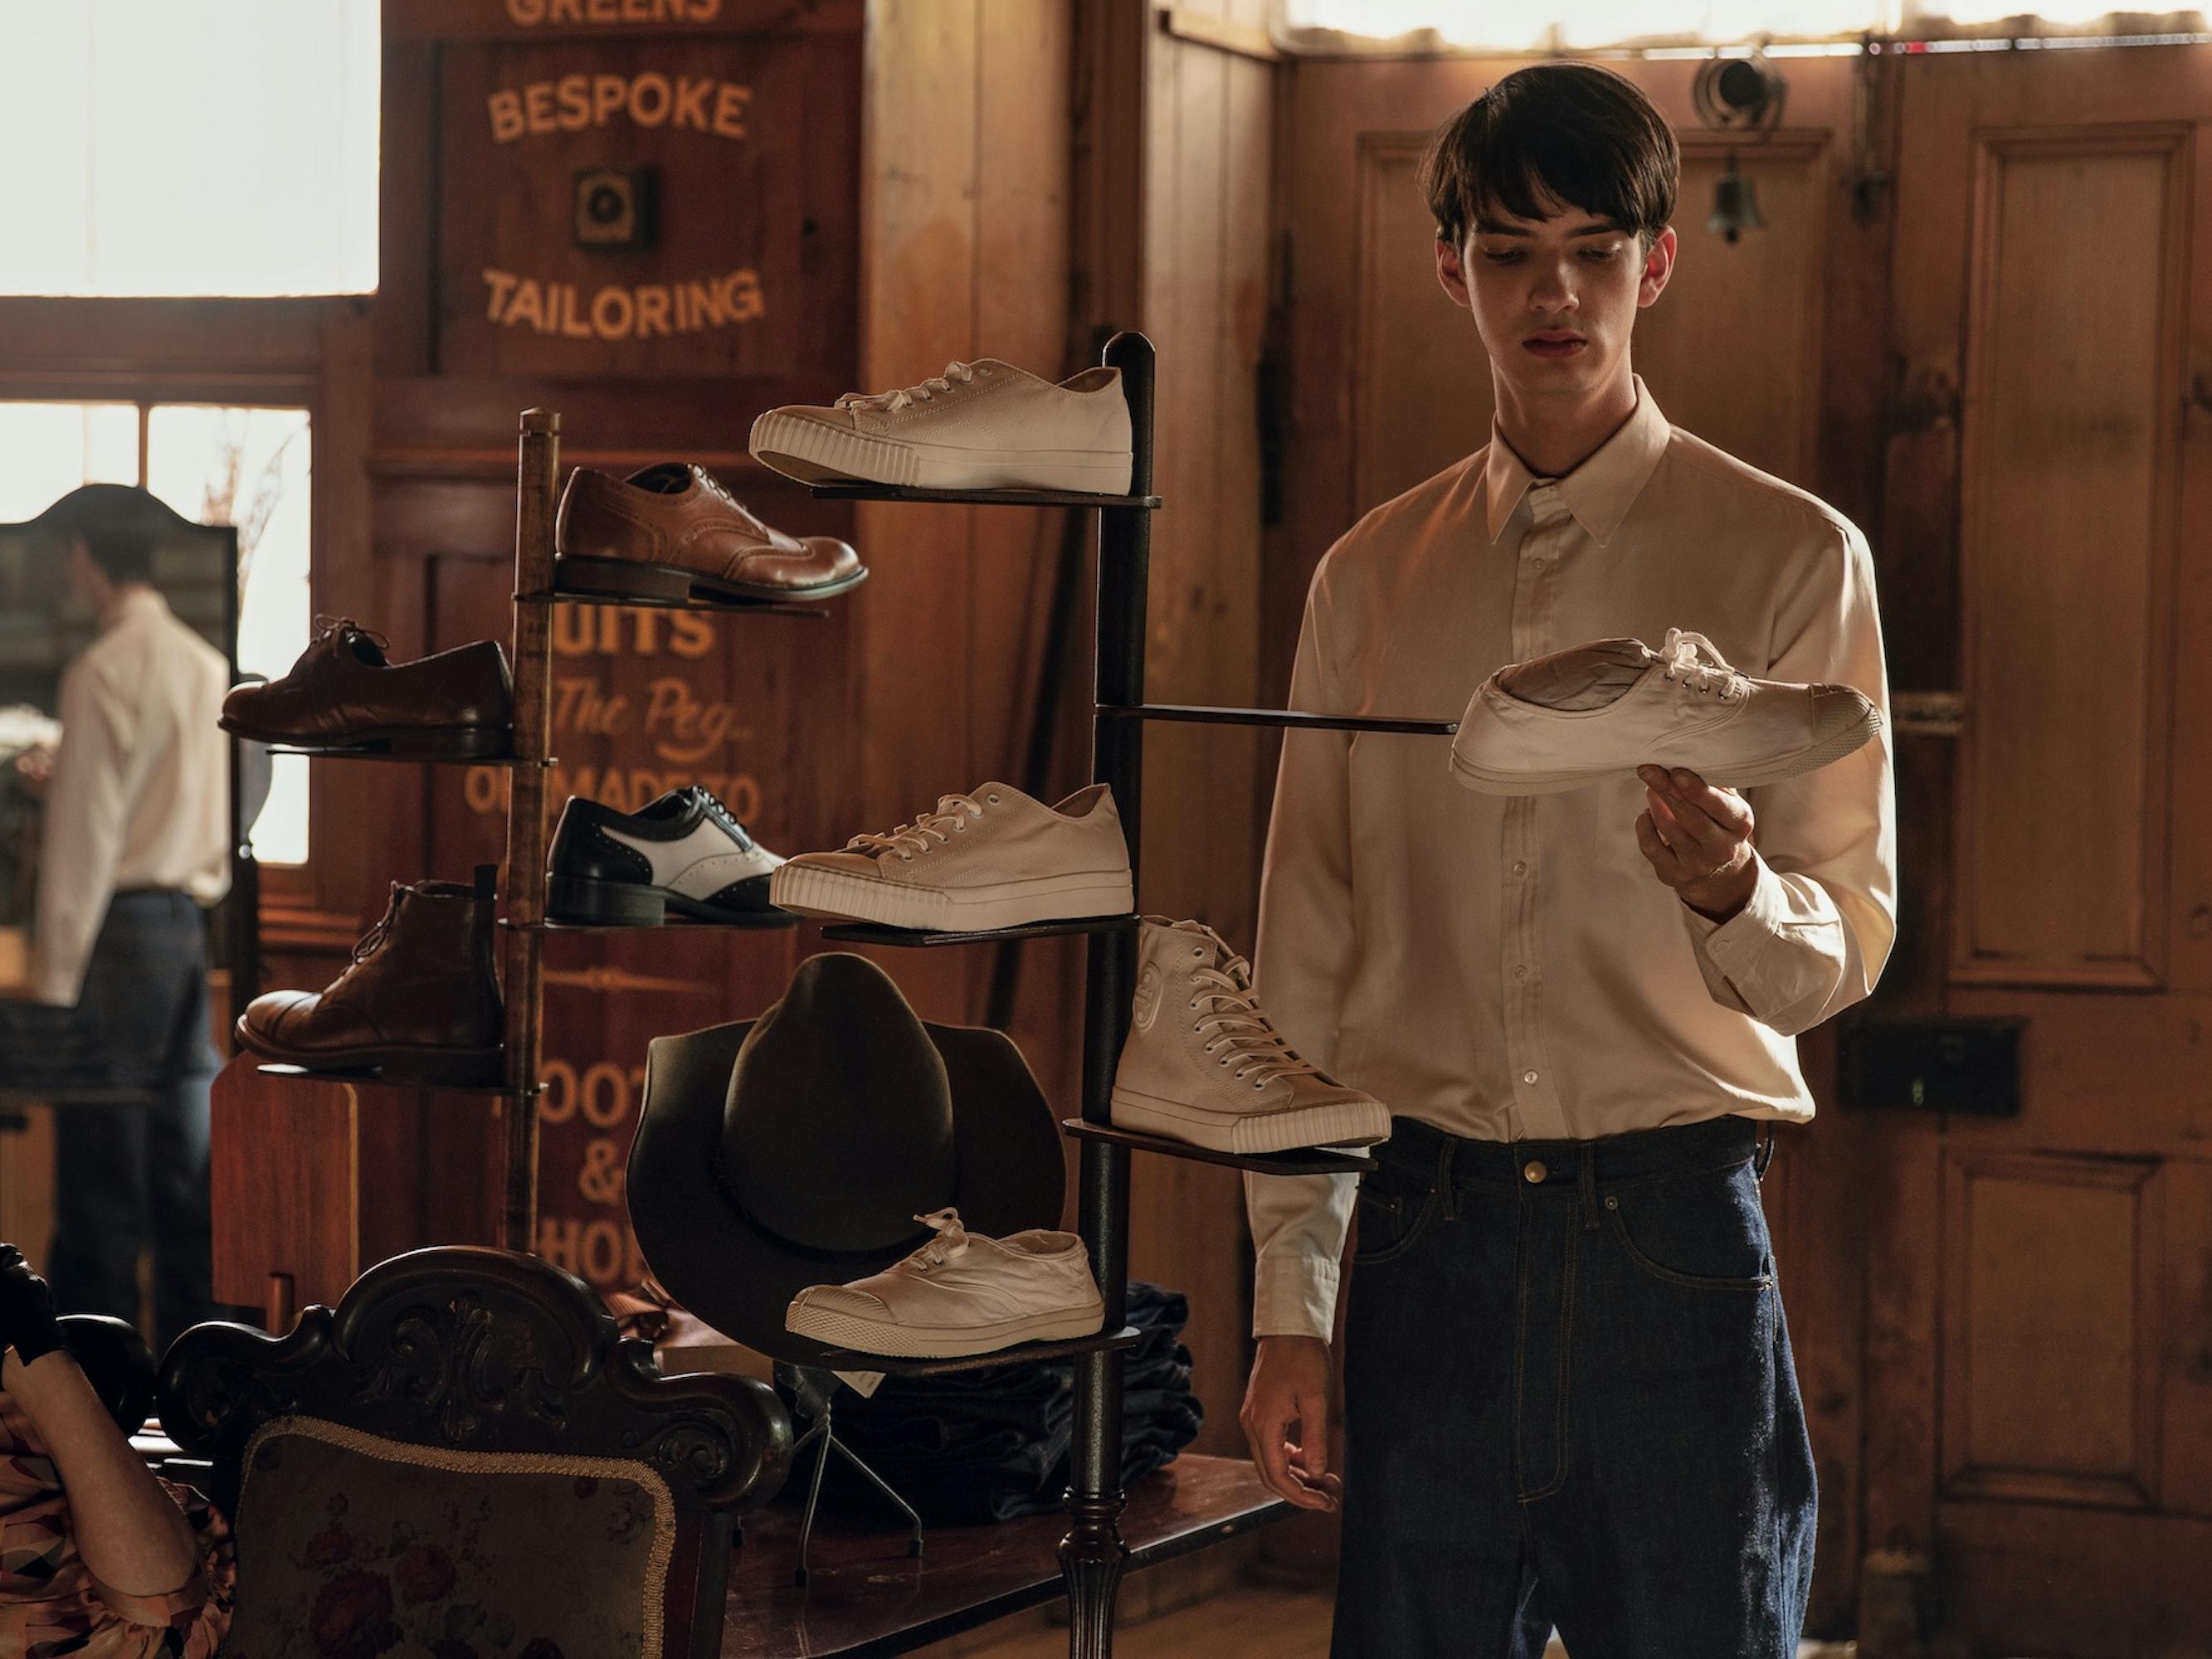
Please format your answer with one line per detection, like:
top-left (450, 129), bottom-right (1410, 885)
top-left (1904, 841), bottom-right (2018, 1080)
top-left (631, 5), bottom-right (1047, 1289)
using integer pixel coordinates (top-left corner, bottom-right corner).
top-left (752, 356), bottom-right (1130, 495)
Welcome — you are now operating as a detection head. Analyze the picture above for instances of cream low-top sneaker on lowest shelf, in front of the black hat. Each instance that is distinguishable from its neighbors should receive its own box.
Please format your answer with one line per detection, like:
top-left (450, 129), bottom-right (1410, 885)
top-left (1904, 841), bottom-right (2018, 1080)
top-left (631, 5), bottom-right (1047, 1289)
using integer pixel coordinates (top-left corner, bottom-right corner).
top-left (783, 1210), bottom-right (1106, 1360)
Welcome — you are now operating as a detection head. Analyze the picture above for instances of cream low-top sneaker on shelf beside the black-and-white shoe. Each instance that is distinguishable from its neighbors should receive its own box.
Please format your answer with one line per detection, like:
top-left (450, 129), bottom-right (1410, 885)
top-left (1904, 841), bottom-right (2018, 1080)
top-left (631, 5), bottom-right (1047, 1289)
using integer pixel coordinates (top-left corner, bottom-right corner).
top-left (767, 783), bottom-right (1135, 933)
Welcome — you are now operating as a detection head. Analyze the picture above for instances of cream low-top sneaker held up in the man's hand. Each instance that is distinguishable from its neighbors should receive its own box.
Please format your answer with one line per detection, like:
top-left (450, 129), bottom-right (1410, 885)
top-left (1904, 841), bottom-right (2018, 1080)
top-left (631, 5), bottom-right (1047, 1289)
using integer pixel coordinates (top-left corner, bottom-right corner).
top-left (1451, 628), bottom-right (1883, 794)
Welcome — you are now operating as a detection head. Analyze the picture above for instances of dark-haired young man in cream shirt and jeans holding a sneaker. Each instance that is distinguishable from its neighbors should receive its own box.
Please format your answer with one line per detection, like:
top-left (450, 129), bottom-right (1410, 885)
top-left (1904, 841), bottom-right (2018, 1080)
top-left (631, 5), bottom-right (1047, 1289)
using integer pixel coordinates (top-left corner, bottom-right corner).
top-left (1243, 64), bottom-right (1896, 1659)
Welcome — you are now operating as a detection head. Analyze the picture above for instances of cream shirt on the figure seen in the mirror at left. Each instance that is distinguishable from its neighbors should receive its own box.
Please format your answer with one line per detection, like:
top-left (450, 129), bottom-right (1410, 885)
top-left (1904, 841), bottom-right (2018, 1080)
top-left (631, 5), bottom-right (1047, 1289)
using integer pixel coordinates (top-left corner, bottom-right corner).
top-left (36, 588), bottom-right (230, 1009)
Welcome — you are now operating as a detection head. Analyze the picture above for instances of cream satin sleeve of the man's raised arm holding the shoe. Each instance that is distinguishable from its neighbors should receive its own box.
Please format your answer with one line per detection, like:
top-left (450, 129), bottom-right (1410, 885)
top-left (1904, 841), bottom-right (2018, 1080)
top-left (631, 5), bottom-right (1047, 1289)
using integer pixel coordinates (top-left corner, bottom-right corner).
top-left (1681, 527), bottom-right (1898, 1038)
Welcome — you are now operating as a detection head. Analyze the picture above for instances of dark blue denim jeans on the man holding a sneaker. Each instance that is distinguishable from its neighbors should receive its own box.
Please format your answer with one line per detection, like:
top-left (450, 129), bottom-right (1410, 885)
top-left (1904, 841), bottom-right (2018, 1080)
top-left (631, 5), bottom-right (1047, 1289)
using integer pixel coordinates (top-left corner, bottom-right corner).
top-left (1332, 1117), bottom-right (1814, 1659)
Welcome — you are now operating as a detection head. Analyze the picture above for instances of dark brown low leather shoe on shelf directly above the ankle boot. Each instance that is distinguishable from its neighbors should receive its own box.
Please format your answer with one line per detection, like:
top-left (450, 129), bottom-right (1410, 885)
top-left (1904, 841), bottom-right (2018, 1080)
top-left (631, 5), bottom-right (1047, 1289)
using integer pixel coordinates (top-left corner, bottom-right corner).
top-left (222, 617), bottom-right (515, 761)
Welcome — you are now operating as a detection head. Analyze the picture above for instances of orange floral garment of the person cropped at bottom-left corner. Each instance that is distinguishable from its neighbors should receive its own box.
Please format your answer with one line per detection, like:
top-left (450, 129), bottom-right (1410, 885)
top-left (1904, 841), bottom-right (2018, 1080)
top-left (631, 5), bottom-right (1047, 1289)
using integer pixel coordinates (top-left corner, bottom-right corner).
top-left (0, 1394), bottom-right (236, 1659)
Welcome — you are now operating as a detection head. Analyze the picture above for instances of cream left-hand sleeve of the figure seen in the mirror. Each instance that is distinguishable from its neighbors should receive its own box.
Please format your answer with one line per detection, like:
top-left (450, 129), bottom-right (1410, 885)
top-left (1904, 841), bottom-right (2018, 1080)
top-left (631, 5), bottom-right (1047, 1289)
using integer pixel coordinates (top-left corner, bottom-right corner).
top-left (37, 661), bottom-right (133, 1009)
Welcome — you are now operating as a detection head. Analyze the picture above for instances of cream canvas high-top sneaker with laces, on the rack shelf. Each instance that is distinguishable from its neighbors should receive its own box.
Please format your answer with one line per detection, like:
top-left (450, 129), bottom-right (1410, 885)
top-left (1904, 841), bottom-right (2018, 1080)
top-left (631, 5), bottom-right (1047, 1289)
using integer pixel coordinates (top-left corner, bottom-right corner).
top-left (1110, 916), bottom-right (1389, 1152)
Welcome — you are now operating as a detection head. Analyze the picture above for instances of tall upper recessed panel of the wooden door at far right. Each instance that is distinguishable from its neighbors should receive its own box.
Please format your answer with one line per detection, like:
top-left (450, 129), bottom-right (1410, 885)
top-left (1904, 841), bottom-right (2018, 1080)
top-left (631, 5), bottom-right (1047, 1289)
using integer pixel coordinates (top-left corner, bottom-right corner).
top-left (1956, 130), bottom-right (2181, 985)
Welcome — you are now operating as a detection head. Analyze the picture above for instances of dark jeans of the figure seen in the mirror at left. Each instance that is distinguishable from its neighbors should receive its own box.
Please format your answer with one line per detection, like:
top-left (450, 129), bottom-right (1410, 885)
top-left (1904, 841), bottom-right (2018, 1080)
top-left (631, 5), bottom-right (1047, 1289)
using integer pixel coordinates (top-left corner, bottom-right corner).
top-left (0, 889), bottom-right (222, 1356)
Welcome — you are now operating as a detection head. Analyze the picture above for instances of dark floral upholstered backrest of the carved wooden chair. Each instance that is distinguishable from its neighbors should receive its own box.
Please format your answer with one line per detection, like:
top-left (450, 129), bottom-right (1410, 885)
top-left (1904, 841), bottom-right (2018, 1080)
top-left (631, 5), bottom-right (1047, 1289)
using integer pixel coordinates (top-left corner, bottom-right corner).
top-left (223, 1418), bottom-right (675, 1659)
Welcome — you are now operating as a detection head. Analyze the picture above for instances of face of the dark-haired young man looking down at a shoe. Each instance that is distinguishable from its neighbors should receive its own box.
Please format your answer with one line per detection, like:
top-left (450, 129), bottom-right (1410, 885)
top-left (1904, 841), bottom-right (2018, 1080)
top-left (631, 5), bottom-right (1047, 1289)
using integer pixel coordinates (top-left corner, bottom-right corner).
top-left (1435, 199), bottom-right (1674, 398)
